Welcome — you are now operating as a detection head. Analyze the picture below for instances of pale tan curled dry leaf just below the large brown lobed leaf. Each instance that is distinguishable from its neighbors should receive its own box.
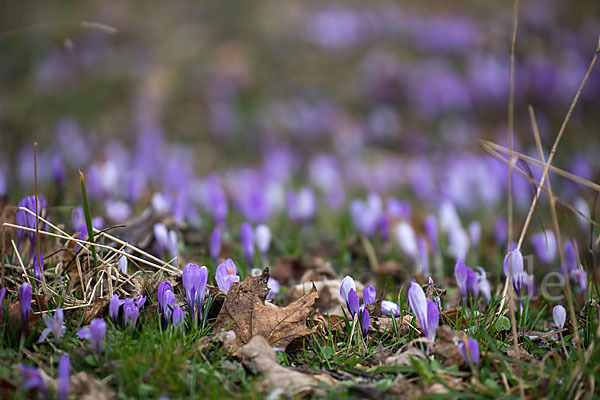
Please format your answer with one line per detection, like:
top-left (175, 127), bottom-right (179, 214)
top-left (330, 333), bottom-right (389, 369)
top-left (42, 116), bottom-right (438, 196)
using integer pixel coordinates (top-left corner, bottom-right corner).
top-left (238, 336), bottom-right (337, 398)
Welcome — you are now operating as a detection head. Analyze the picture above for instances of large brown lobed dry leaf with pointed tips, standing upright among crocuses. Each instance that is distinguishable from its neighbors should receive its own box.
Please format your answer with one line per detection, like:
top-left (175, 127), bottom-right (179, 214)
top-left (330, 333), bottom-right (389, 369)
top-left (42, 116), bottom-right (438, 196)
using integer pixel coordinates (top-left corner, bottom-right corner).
top-left (214, 268), bottom-right (319, 349)
